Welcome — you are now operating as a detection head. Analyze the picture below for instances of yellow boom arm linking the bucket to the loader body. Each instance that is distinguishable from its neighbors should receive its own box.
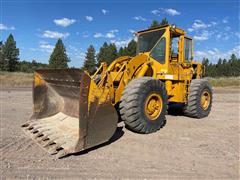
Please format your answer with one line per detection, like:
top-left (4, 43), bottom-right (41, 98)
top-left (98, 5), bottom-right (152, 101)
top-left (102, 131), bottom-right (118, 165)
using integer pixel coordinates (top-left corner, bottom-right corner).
top-left (92, 54), bottom-right (150, 105)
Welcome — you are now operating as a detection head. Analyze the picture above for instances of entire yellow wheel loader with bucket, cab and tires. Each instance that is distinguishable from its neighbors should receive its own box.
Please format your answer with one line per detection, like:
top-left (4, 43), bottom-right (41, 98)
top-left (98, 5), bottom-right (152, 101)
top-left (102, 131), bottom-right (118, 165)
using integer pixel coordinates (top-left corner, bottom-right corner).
top-left (22, 25), bottom-right (212, 157)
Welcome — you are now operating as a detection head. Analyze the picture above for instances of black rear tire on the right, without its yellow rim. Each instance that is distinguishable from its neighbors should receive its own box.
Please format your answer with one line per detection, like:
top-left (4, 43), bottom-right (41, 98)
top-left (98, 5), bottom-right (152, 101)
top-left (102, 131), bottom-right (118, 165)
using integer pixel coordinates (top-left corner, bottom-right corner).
top-left (183, 79), bottom-right (212, 118)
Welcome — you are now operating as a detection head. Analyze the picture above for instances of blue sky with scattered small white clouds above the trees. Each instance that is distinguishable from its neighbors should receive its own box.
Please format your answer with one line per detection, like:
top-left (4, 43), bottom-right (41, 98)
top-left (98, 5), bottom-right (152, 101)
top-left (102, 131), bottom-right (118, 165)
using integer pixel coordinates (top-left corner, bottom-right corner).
top-left (0, 0), bottom-right (240, 67)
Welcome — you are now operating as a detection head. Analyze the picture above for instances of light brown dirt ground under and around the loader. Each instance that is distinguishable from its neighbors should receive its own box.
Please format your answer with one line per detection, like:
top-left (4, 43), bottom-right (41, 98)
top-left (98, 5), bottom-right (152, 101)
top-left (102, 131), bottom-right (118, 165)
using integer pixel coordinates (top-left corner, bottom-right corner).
top-left (0, 88), bottom-right (240, 179)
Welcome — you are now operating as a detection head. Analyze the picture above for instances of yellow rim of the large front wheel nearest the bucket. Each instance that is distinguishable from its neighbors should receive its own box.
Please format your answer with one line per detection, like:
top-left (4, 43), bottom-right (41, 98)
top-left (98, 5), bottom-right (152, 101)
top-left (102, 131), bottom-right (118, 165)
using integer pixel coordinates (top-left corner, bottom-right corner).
top-left (144, 93), bottom-right (163, 121)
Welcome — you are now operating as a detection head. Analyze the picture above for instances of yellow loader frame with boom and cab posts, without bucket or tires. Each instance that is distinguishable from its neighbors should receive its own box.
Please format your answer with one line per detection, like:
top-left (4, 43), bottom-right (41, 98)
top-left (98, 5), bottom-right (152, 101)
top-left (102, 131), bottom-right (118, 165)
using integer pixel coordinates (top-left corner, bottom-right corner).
top-left (93, 26), bottom-right (202, 105)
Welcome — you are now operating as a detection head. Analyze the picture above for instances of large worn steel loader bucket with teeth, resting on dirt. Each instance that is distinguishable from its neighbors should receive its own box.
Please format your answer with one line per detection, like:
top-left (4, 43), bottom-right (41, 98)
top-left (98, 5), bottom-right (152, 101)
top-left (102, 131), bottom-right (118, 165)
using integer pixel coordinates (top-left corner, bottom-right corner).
top-left (22, 69), bottom-right (118, 157)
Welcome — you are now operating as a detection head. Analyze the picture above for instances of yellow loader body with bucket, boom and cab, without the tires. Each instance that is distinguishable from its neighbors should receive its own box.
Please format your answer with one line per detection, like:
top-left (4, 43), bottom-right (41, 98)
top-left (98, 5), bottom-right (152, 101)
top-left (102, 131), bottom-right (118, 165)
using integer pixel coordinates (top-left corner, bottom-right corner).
top-left (22, 25), bottom-right (202, 157)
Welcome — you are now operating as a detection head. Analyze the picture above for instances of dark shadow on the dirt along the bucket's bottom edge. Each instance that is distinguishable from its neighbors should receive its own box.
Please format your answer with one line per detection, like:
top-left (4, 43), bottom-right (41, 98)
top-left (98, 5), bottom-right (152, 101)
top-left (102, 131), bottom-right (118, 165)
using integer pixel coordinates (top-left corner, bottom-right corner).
top-left (60, 126), bottom-right (124, 159)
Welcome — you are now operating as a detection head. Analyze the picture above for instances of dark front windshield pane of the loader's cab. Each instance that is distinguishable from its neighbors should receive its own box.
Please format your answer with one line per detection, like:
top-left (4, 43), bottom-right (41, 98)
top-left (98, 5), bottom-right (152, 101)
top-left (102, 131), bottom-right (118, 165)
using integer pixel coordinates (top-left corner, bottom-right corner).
top-left (137, 29), bottom-right (165, 53)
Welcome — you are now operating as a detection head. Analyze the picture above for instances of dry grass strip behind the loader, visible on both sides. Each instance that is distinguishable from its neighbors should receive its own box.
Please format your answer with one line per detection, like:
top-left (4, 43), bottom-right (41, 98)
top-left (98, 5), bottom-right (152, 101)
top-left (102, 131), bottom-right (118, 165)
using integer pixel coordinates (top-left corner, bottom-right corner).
top-left (0, 72), bottom-right (240, 87)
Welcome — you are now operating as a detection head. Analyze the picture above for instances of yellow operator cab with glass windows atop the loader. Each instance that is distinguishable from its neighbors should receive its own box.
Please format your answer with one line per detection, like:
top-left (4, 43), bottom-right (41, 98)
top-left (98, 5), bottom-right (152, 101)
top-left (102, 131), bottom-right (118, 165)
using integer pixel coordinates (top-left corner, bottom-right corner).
top-left (136, 25), bottom-right (193, 64)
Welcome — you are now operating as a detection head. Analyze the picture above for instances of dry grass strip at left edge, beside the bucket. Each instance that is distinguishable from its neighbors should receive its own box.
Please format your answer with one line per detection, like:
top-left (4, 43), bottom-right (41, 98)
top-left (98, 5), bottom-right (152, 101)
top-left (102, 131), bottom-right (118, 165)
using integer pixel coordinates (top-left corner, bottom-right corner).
top-left (0, 71), bottom-right (33, 88)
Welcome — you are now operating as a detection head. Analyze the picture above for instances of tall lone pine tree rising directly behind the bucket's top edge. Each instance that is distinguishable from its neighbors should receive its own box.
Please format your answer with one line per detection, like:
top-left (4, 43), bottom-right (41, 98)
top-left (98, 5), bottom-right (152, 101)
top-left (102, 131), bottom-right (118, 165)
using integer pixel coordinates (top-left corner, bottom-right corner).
top-left (49, 39), bottom-right (70, 68)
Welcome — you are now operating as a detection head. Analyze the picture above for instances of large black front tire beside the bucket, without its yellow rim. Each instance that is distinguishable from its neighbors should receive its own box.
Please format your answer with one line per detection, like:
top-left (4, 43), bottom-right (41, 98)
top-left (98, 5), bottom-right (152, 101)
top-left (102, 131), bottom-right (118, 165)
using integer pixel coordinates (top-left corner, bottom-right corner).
top-left (119, 77), bottom-right (167, 134)
